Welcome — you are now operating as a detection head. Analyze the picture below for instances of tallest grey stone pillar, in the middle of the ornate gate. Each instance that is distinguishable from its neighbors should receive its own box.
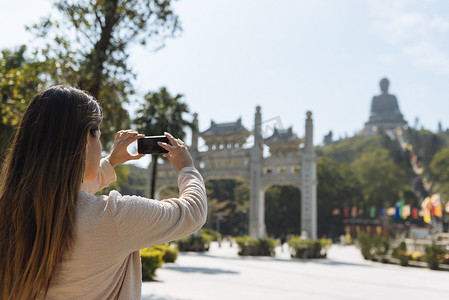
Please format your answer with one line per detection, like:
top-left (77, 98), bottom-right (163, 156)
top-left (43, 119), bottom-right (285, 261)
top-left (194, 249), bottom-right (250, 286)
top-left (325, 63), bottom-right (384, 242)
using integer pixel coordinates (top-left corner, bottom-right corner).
top-left (249, 106), bottom-right (265, 238)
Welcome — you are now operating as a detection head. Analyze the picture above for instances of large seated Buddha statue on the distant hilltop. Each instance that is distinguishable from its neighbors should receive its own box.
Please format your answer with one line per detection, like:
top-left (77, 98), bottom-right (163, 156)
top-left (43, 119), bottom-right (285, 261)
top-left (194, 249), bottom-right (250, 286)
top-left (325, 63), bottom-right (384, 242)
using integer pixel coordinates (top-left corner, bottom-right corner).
top-left (362, 78), bottom-right (407, 133)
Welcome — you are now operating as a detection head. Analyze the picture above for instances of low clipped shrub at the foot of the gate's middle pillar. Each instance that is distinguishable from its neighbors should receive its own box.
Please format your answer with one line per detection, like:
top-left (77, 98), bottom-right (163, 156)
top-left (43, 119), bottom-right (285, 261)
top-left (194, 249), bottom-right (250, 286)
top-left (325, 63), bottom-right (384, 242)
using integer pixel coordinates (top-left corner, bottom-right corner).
top-left (235, 235), bottom-right (278, 256)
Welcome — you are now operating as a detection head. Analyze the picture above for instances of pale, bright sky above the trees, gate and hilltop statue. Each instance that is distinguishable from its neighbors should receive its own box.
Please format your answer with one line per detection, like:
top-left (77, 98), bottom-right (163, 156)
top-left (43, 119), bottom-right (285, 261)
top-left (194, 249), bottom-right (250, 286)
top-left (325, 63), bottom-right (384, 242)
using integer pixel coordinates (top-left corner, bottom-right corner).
top-left (0, 0), bottom-right (449, 149)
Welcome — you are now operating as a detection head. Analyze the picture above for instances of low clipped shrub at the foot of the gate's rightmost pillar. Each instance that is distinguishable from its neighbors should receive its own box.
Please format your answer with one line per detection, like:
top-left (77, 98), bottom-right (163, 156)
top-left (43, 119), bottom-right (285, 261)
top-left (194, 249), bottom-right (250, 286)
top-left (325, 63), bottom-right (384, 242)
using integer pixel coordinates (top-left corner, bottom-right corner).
top-left (287, 236), bottom-right (332, 258)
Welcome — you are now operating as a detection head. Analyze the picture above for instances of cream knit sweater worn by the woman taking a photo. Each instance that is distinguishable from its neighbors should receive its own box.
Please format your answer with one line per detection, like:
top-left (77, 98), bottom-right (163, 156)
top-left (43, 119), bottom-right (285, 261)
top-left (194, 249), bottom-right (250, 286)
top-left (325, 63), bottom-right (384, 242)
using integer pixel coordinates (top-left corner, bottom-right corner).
top-left (45, 159), bottom-right (207, 299)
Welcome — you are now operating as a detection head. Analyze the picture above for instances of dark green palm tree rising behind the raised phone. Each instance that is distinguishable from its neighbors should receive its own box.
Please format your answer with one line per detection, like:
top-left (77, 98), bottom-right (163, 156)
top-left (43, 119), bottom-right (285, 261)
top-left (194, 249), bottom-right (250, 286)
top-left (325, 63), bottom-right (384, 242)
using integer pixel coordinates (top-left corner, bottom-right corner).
top-left (134, 87), bottom-right (193, 198)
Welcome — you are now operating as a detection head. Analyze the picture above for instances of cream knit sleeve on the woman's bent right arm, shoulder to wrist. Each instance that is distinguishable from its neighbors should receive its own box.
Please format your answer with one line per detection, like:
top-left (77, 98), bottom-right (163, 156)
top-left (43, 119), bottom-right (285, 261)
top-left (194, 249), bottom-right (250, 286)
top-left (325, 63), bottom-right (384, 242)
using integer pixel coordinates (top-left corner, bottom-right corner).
top-left (108, 167), bottom-right (207, 252)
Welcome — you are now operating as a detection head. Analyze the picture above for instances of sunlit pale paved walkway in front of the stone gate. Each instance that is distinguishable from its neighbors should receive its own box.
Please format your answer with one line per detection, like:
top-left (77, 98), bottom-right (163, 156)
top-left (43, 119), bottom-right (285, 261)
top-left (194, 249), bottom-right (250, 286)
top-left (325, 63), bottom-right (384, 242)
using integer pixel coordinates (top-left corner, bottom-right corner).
top-left (142, 243), bottom-right (449, 300)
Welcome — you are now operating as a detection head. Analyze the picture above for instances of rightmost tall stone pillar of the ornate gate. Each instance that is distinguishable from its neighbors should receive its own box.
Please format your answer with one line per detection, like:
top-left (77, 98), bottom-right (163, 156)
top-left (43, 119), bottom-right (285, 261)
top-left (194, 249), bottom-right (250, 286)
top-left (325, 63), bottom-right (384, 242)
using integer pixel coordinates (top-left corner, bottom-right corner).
top-left (301, 111), bottom-right (317, 239)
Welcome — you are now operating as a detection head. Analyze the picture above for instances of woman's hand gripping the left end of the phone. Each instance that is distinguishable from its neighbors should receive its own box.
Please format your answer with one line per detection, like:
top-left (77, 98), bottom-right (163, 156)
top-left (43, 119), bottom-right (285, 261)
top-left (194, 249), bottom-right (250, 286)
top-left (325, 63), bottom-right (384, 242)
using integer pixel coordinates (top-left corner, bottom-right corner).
top-left (107, 130), bottom-right (145, 167)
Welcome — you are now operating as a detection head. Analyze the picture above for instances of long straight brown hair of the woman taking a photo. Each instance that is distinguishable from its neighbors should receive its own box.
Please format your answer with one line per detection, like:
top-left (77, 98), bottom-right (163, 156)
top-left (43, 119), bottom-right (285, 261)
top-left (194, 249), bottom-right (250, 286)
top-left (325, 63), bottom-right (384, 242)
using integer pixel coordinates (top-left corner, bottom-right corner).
top-left (0, 86), bottom-right (102, 300)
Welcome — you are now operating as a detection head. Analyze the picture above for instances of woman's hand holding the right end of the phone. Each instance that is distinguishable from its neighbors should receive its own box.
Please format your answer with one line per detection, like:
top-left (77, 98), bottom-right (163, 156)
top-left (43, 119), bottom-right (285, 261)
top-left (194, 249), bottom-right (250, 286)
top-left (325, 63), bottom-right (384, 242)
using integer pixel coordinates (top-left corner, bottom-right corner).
top-left (158, 132), bottom-right (194, 171)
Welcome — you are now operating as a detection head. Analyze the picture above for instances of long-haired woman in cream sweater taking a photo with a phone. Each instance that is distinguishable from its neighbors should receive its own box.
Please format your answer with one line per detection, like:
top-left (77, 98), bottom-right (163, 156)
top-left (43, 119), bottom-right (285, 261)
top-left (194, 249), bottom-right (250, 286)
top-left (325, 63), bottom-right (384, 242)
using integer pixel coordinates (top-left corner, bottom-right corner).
top-left (0, 86), bottom-right (207, 300)
